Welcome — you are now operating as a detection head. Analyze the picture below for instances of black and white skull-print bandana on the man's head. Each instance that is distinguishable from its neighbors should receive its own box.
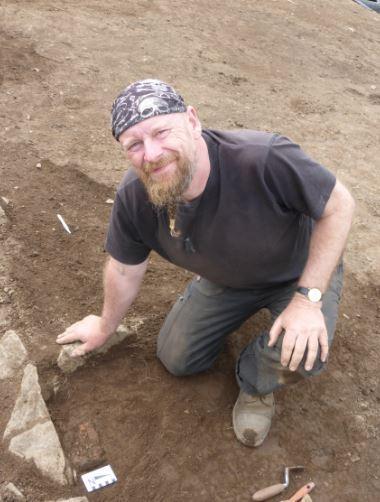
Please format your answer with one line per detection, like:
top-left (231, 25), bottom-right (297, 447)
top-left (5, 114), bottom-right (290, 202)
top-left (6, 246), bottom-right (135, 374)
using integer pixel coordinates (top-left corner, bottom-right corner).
top-left (111, 79), bottom-right (186, 140)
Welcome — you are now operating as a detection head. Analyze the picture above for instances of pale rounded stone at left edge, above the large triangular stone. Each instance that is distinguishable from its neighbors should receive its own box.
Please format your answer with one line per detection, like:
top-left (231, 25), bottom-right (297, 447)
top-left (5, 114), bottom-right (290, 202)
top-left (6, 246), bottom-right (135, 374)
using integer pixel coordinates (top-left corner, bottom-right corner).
top-left (0, 330), bottom-right (27, 380)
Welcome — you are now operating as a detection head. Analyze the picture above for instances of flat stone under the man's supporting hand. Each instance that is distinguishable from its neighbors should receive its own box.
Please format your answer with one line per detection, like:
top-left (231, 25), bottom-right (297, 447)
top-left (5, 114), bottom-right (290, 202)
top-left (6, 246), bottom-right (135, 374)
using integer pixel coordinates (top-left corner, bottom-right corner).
top-left (57, 319), bottom-right (143, 373)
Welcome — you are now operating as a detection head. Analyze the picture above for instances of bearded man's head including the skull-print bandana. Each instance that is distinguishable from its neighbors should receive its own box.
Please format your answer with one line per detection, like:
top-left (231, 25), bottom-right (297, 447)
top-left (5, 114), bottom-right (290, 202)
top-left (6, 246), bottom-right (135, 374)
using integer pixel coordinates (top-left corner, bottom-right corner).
top-left (112, 80), bottom-right (201, 206)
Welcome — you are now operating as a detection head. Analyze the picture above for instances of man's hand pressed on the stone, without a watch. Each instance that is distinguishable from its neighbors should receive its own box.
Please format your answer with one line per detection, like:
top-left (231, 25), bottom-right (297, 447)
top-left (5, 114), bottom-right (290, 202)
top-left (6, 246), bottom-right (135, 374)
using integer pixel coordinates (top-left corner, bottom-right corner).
top-left (56, 315), bottom-right (110, 357)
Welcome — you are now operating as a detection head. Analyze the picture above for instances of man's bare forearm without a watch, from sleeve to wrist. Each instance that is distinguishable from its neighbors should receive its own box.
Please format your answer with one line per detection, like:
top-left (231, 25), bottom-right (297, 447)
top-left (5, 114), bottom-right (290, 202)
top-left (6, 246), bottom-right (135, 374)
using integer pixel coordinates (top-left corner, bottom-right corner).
top-left (101, 258), bottom-right (148, 336)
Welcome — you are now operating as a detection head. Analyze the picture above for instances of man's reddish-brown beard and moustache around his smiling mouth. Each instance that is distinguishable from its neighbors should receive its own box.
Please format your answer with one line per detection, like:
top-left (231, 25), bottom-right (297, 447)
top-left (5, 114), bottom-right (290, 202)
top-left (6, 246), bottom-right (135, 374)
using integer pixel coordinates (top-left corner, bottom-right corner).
top-left (138, 152), bottom-right (195, 208)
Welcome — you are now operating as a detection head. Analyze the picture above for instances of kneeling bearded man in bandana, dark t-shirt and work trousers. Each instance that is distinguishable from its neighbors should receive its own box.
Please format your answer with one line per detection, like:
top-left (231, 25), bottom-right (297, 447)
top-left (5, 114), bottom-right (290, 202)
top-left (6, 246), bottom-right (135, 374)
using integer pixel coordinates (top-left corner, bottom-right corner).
top-left (57, 80), bottom-right (354, 446)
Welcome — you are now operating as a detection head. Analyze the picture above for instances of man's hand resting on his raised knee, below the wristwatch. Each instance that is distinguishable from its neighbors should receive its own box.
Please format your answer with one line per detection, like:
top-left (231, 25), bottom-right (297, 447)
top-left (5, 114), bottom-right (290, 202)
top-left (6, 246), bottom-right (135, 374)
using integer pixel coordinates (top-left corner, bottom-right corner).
top-left (268, 294), bottom-right (329, 371)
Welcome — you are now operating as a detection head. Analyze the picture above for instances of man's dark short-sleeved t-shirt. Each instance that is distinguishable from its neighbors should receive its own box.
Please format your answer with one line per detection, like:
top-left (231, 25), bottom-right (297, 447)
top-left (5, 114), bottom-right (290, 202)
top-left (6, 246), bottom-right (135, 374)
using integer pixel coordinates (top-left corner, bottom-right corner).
top-left (106, 129), bottom-right (335, 288)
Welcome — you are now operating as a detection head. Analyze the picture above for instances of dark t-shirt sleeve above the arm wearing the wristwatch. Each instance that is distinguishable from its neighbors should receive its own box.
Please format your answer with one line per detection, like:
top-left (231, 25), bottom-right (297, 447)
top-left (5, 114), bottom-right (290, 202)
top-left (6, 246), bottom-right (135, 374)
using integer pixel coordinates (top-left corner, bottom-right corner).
top-left (264, 135), bottom-right (336, 220)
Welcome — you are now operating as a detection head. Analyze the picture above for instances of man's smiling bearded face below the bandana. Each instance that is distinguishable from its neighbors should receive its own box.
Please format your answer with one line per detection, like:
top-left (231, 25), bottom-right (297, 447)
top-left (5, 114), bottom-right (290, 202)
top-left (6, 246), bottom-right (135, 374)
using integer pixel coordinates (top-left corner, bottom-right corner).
top-left (119, 113), bottom-right (196, 206)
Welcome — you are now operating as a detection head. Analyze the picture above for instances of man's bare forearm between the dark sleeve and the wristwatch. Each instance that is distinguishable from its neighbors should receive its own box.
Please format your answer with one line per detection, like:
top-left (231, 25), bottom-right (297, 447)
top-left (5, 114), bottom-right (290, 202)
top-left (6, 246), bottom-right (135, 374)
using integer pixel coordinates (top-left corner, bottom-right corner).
top-left (299, 179), bottom-right (355, 291)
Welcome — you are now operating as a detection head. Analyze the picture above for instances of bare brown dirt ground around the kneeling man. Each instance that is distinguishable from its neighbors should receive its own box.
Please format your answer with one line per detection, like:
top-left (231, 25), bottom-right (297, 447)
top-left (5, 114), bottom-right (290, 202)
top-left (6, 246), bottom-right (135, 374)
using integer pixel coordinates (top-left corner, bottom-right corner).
top-left (0, 0), bottom-right (380, 502)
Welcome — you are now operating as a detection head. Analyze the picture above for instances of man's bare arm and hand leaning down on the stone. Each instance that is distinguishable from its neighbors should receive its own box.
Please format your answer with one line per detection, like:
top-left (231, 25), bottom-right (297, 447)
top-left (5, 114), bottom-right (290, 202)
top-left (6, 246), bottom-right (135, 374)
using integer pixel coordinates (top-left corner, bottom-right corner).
top-left (57, 258), bottom-right (148, 357)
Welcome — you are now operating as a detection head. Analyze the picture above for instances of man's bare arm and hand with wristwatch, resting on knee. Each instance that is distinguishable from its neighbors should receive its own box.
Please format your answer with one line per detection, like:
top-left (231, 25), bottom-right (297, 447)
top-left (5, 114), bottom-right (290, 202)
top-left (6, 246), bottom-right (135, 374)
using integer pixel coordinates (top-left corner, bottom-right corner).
top-left (269, 181), bottom-right (355, 371)
